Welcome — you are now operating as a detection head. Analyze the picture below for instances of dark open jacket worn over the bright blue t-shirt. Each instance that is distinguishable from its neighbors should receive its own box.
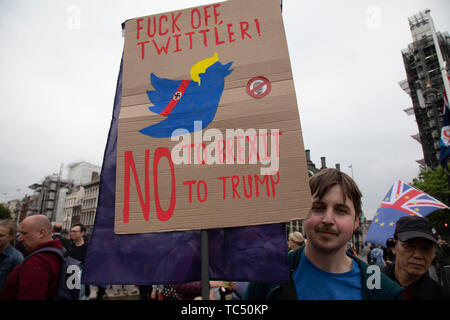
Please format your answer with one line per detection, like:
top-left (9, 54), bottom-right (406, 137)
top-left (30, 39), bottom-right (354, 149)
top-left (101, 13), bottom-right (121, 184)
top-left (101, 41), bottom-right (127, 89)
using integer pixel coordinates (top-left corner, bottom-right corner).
top-left (244, 247), bottom-right (403, 300)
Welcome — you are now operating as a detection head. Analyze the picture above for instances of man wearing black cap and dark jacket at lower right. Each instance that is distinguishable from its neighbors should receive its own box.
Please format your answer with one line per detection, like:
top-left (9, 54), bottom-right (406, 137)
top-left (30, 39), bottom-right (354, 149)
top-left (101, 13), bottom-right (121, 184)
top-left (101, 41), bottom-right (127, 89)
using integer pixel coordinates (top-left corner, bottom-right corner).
top-left (386, 216), bottom-right (450, 300)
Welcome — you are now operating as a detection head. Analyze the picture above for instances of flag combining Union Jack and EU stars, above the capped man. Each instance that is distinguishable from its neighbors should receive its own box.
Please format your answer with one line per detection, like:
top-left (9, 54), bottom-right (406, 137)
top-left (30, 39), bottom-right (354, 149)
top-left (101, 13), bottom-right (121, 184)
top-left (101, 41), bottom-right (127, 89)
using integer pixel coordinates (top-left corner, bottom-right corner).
top-left (365, 179), bottom-right (448, 246)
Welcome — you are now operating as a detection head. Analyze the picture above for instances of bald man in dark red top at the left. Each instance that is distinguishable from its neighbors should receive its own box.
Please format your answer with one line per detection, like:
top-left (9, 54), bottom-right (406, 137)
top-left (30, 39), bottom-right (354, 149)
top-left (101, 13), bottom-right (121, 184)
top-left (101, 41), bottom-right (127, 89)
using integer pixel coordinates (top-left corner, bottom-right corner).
top-left (0, 215), bottom-right (62, 300)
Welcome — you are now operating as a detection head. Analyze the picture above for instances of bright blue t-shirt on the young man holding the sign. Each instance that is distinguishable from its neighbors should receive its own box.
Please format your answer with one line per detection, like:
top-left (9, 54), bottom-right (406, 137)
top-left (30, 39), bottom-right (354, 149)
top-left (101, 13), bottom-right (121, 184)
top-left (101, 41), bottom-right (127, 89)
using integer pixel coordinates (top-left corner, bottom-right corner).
top-left (293, 250), bottom-right (362, 300)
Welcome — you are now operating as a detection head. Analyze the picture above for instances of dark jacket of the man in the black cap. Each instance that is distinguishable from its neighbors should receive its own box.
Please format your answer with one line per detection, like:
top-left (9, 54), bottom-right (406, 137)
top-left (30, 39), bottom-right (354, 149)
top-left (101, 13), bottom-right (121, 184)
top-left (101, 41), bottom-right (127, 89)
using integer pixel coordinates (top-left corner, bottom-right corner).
top-left (385, 264), bottom-right (450, 300)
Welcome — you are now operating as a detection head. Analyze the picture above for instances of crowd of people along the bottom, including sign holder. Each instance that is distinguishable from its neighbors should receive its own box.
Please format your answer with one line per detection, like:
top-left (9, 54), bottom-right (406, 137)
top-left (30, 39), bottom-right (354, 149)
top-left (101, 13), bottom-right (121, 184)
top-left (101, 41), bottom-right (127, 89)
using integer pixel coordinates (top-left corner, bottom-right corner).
top-left (0, 169), bottom-right (450, 300)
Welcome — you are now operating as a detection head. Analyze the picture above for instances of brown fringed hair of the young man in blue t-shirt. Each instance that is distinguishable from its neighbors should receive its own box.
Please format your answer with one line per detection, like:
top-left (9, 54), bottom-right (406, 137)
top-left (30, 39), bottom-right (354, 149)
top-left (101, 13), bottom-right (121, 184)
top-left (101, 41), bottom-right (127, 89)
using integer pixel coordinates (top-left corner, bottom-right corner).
top-left (309, 168), bottom-right (362, 217)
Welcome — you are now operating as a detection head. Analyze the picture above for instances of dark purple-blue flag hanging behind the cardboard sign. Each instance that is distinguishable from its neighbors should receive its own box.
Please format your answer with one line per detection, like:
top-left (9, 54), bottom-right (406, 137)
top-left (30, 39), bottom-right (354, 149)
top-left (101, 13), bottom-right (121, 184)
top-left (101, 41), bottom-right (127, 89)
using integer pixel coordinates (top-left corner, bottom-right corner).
top-left (82, 55), bottom-right (289, 285)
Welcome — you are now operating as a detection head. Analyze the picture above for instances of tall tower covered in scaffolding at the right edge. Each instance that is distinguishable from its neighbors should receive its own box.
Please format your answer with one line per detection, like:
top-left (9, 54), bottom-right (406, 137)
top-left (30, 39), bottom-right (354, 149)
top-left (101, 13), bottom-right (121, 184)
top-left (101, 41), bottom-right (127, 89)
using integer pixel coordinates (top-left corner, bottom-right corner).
top-left (399, 10), bottom-right (450, 169)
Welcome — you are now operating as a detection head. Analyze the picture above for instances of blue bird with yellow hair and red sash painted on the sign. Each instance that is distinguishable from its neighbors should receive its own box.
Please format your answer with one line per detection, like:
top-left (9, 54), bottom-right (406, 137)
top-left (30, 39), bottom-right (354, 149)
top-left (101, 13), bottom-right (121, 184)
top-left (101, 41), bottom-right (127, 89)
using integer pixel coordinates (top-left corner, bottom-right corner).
top-left (139, 53), bottom-right (233, 138)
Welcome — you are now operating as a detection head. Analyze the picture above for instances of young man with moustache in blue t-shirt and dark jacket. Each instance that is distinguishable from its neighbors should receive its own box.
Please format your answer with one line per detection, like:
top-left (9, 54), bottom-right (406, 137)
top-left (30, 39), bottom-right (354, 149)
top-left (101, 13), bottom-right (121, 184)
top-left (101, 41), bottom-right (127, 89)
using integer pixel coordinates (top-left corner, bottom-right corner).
top-left (246, 169), bottom-right (403, 300)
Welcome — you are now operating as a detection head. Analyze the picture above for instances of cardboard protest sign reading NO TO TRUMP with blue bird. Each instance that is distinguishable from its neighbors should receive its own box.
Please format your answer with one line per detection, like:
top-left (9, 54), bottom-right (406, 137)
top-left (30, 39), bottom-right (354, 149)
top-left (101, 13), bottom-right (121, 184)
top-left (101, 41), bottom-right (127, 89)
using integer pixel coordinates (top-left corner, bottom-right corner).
top-left (114, 0), bottom-right (311, 234)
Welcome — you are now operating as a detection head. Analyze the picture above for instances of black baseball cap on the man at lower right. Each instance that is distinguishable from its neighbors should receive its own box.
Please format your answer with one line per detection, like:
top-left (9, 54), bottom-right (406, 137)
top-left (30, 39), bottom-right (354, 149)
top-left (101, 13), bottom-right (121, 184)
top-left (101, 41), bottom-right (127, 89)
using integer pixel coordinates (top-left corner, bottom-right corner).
top-left (394, 216), bottom-right (438, 244)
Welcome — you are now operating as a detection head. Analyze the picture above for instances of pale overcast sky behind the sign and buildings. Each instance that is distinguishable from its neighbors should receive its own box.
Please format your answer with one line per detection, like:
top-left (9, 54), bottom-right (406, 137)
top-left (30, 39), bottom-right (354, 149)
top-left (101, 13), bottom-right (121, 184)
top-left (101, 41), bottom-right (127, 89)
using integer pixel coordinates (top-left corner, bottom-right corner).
top-left (0, 0), bottom-right (450, 218)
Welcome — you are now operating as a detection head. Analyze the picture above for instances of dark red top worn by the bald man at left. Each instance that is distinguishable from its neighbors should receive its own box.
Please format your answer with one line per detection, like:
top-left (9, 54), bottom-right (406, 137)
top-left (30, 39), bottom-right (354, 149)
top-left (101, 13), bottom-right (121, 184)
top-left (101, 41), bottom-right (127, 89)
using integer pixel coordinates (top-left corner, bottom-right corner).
top-left (0, 240), bottom-right (62, 300)
